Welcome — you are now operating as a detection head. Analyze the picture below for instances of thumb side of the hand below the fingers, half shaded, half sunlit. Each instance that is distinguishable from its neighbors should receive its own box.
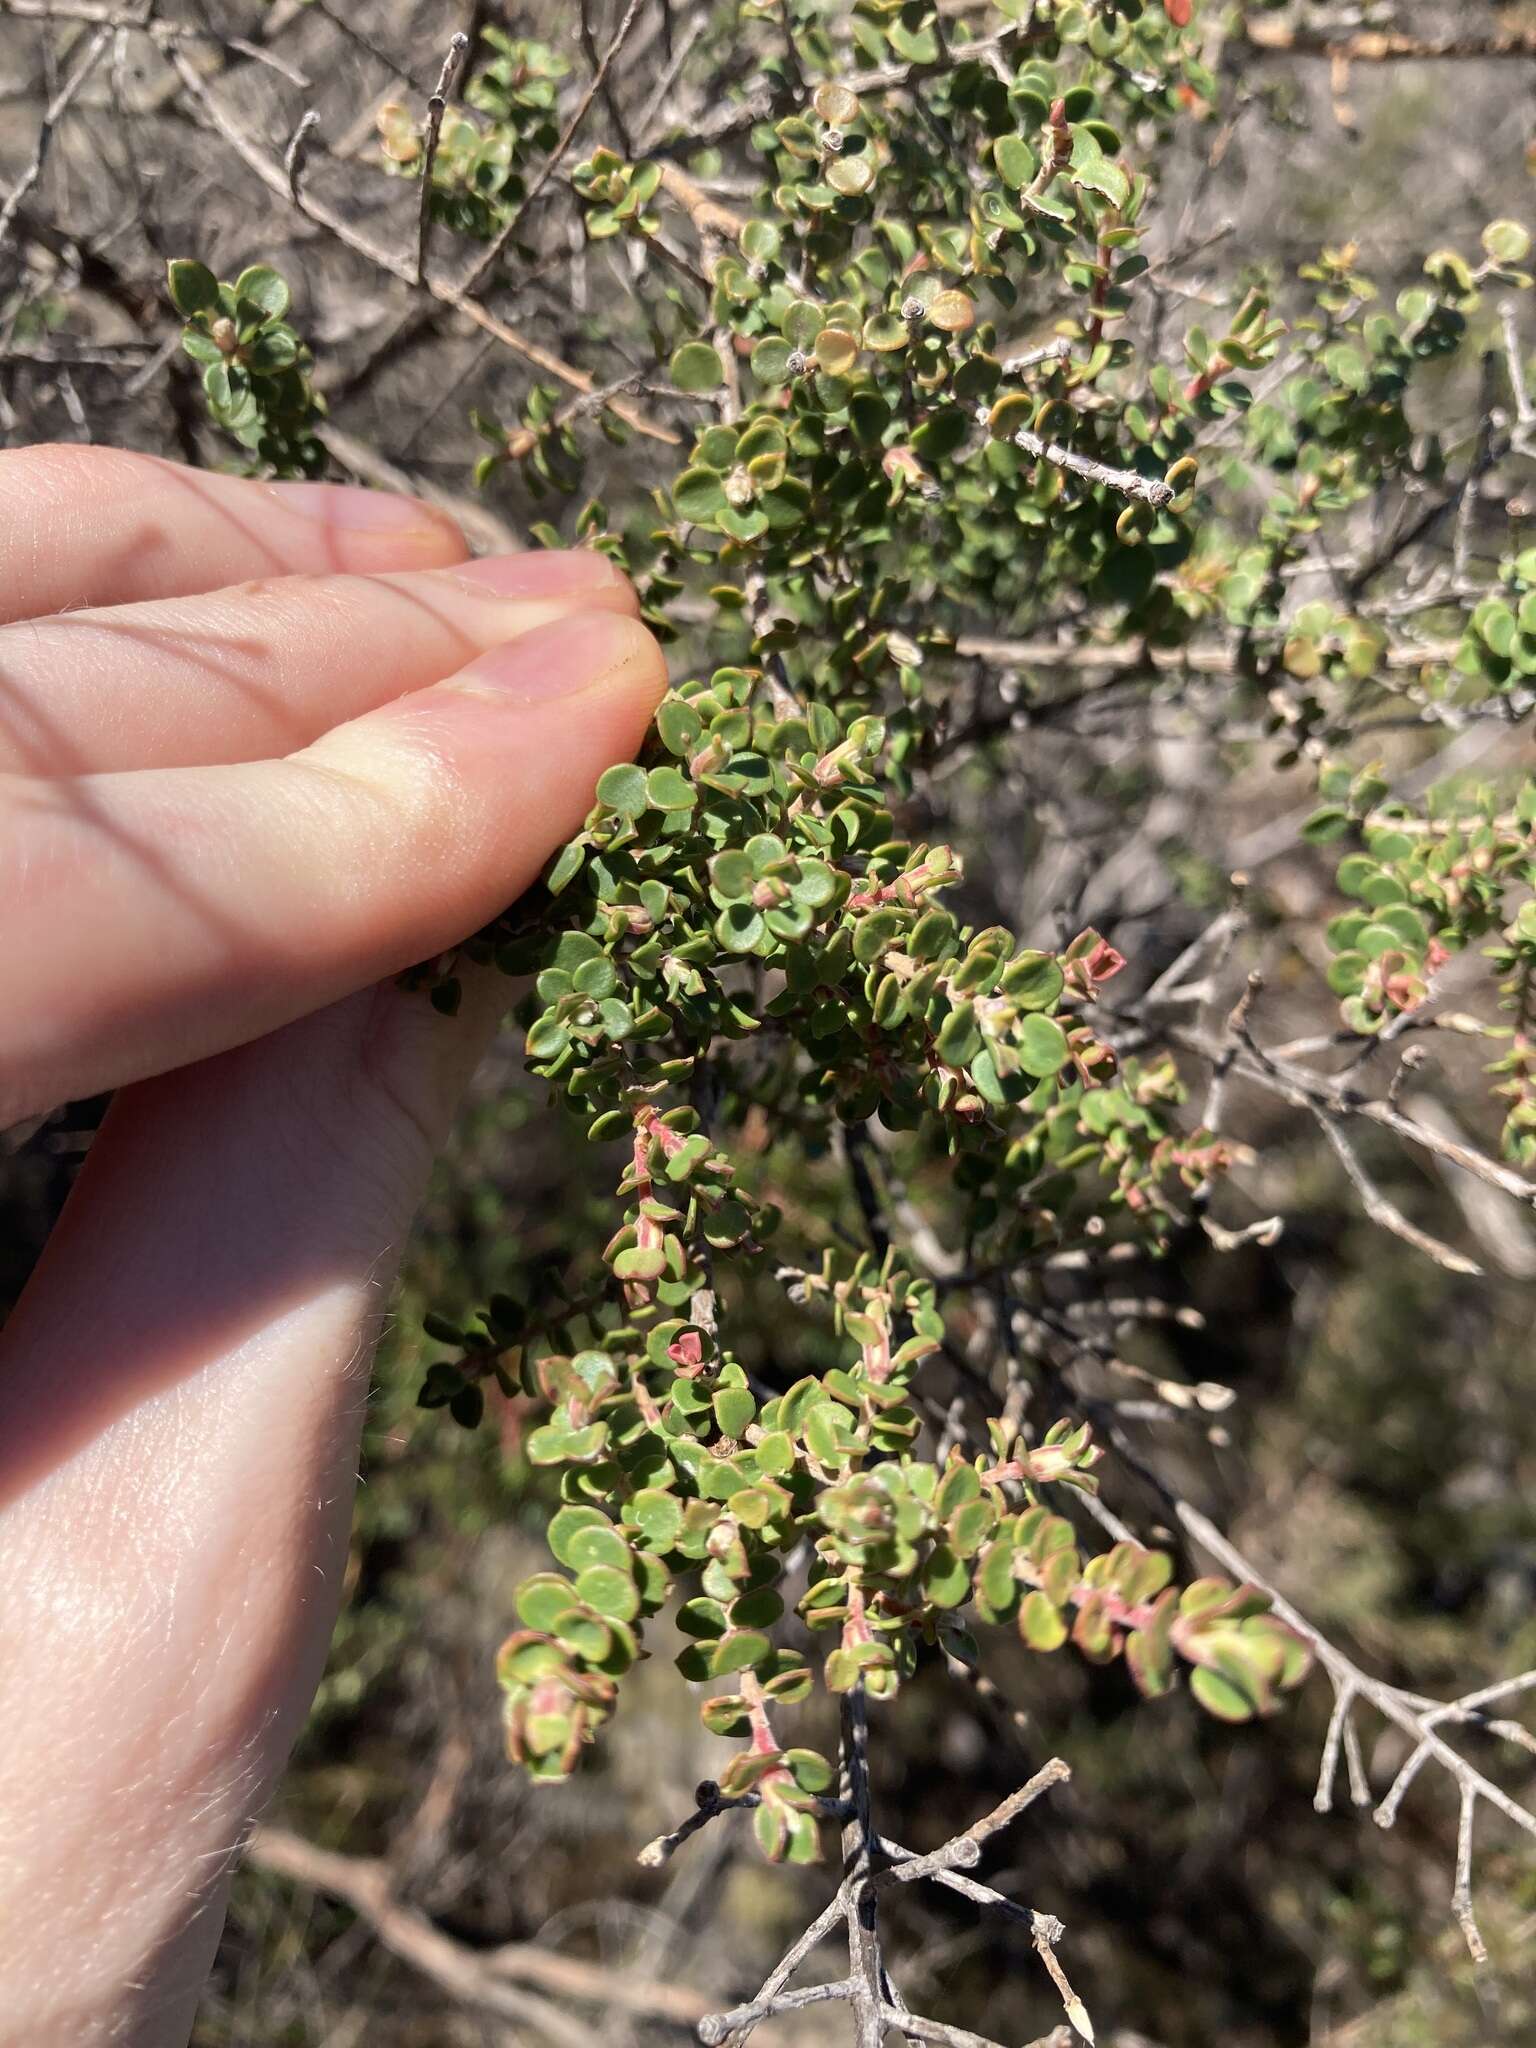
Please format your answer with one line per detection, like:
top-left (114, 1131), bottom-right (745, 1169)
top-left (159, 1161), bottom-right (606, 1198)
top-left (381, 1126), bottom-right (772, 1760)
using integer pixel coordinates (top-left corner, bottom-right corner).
top-left (0, 971), bottom-right (506, 2048)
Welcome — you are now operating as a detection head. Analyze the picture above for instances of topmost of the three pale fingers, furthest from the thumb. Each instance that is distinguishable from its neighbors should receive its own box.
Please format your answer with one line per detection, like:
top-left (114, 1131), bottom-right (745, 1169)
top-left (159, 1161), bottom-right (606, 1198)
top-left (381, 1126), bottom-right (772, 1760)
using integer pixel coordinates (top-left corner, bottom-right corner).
top-left (0, 442), bottom-right (469, 623)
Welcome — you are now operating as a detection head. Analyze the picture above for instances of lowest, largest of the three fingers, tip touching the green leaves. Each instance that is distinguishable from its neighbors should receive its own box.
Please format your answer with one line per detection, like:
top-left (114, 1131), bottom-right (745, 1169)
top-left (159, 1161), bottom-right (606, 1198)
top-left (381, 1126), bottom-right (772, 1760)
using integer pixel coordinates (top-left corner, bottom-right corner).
top-left (0, 612), bottom-right (666, 1124)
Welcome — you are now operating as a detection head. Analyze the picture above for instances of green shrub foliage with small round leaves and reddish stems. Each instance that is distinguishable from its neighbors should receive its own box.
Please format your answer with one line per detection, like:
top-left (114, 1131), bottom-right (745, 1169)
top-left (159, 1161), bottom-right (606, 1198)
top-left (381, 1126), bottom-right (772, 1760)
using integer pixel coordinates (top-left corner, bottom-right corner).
top-left (172, 0), bottom-right (1536, 1998)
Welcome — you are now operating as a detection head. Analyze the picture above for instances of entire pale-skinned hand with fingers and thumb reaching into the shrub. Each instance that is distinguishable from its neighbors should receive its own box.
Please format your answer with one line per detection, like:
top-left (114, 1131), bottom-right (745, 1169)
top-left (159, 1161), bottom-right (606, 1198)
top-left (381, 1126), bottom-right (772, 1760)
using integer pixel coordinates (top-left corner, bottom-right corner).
top-left (0, 449), bottom-right (666, 2048)
